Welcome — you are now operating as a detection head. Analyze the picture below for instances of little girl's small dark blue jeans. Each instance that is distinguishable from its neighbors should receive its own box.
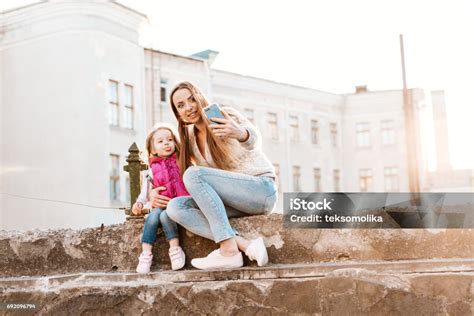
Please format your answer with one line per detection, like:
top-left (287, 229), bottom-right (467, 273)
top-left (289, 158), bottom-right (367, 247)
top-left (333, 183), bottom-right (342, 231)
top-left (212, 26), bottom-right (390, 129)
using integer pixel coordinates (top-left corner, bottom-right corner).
top-left (142, 208), bottom-right (179, 245)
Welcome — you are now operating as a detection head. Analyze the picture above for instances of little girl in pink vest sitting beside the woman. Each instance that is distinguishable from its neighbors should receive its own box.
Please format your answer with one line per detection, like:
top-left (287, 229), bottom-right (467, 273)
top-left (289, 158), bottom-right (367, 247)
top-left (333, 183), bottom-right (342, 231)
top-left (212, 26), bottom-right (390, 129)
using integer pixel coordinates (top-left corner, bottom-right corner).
top-left (132, 125), bottom-right (189, 273)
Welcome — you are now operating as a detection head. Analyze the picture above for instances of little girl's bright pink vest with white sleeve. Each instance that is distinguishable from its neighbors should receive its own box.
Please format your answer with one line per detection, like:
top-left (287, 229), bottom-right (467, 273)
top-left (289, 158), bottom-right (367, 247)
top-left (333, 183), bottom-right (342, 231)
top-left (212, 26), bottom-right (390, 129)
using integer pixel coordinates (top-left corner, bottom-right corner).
top-left (137, 153), bottom-right (190, 208)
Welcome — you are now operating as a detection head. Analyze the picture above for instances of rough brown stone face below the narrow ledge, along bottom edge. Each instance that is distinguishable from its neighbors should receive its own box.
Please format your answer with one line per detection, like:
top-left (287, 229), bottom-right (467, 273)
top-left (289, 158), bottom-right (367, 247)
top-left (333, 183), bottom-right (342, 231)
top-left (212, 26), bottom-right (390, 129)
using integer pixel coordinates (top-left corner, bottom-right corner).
top-left (0, 269), bottom-right (474, 315)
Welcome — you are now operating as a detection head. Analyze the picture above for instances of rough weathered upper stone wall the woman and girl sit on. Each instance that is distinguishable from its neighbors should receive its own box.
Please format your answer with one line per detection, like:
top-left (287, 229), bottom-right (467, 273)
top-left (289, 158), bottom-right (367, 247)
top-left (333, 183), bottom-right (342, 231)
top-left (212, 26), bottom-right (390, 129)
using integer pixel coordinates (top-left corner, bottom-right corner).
top-left (0, 214), bottom-right (474, 276)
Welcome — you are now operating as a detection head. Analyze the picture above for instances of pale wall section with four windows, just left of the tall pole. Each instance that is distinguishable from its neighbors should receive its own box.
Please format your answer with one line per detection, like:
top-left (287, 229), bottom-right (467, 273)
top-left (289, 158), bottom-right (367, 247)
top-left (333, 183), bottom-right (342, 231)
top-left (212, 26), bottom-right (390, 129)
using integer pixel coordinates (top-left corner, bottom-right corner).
top-left (343, 91), bottom-right (408, 192)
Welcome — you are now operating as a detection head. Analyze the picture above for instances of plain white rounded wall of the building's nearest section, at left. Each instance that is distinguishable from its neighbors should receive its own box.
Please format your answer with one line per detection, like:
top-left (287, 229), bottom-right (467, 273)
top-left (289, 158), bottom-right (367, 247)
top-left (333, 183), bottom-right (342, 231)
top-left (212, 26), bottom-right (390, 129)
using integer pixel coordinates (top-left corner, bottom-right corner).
top-left (0, 1), bottom-right (144, 229)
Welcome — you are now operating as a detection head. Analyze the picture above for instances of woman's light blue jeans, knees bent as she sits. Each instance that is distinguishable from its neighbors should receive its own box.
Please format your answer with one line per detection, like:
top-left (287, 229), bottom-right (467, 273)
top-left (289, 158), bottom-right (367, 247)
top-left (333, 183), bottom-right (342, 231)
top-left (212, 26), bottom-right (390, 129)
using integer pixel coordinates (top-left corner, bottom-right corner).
top-left (166, 166), bottom-right (278, 243)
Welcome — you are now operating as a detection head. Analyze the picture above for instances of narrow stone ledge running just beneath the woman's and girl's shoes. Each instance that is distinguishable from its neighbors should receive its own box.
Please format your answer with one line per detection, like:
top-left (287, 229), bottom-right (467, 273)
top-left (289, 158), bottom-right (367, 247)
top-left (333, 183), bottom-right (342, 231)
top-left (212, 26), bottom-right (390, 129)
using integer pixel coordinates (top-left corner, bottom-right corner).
top-left (0, 259), bottom-right (474, 292)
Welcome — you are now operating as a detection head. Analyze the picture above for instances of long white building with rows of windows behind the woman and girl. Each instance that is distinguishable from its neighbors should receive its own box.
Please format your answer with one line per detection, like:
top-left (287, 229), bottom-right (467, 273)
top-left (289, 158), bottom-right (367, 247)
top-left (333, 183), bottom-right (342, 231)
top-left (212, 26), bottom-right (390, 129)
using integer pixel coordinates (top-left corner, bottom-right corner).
top-left (0, 1), bottom-right (471, 229)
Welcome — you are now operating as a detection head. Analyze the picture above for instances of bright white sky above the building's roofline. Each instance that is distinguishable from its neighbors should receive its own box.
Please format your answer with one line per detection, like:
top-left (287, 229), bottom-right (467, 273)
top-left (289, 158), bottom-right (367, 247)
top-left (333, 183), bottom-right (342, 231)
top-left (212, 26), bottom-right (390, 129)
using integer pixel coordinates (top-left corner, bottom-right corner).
top-left (0, 0), bottom-right (474, 168)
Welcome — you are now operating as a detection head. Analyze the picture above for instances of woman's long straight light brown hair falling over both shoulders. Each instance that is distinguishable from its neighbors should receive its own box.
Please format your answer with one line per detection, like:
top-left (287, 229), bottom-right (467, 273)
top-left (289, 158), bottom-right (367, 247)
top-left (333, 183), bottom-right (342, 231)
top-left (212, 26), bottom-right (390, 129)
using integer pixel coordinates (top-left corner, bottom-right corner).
top-left (170, 81), bottom-right (234, 174)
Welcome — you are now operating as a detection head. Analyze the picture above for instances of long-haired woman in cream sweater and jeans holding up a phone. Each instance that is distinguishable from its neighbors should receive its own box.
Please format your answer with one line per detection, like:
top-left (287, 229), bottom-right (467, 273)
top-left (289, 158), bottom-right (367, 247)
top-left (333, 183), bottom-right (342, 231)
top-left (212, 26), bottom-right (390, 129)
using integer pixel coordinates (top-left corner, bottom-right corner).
top-left (151, 82), bottom-right (277, 269)
